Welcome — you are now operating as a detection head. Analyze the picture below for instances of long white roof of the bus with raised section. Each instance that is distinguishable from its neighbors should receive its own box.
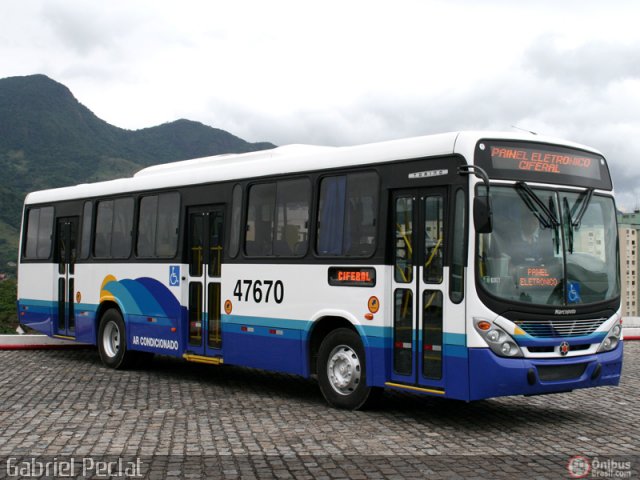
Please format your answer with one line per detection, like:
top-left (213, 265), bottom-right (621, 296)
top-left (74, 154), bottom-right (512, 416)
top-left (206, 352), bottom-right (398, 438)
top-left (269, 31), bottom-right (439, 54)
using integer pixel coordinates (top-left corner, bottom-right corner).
top-left (25, 131), bottom-right (599, 204)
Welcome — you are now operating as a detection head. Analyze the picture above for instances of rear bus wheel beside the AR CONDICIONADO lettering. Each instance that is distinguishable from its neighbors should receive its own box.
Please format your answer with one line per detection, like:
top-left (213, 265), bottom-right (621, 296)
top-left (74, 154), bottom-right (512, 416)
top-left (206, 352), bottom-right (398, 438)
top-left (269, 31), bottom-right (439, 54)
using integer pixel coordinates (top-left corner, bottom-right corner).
top-left (98, 308), bottom-right (135, 369)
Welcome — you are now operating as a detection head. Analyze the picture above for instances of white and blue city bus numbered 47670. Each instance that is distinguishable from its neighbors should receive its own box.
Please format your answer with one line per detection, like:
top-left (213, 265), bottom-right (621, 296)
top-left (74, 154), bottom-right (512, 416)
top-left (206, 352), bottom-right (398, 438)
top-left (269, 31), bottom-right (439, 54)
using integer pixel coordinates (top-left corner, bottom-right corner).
top-left (18, 132), bottom-right (623, 409)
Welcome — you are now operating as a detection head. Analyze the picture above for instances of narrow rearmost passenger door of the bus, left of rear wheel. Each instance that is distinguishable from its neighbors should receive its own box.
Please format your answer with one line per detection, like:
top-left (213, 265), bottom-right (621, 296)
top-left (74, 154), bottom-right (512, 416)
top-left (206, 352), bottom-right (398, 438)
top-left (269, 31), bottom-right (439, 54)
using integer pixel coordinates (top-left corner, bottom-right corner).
top-left (55, 217), bottom-right (79, 337)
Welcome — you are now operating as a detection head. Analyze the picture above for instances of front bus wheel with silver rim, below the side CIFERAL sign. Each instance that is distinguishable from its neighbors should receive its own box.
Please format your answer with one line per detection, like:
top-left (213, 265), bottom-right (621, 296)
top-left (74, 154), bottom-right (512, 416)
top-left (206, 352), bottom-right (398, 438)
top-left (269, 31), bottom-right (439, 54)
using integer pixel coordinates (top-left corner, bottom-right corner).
top-left (317, 328), bottom-right (382, 410)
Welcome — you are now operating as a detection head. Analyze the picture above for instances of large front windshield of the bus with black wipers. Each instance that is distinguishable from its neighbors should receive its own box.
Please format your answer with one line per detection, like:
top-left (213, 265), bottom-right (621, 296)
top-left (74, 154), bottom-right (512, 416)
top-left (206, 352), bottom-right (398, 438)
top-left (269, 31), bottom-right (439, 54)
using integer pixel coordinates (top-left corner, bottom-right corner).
top-left (476, 186), bottom-right (620, 306)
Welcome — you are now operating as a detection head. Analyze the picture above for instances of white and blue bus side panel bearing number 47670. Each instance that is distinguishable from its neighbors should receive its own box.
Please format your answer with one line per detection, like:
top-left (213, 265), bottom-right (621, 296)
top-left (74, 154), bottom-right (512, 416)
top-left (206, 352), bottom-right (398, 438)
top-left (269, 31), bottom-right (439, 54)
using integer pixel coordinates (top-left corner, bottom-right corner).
top-left (222, 262), bottom-right (386, 378)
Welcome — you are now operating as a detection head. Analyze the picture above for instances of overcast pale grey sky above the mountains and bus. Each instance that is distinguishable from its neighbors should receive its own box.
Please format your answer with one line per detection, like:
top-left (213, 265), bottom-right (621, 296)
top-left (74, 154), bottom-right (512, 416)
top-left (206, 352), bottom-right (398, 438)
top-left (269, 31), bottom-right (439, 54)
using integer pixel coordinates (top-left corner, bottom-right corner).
top-left (0, 0), bottom-right (640, 210)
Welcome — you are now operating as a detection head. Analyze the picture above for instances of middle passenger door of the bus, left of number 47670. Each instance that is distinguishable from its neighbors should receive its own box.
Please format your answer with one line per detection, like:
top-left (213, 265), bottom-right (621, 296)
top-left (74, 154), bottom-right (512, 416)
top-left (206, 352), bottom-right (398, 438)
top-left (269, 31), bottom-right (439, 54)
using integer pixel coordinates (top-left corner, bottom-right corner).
top-left (187, 206), bottom-right (224, 356)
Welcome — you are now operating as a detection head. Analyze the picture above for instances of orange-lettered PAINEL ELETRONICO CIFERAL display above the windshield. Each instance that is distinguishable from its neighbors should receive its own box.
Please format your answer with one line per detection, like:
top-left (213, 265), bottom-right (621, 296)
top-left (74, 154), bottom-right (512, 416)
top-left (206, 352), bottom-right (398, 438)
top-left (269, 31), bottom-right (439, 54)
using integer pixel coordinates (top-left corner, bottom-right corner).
top-left (489, 145), bottom-right (601, 180)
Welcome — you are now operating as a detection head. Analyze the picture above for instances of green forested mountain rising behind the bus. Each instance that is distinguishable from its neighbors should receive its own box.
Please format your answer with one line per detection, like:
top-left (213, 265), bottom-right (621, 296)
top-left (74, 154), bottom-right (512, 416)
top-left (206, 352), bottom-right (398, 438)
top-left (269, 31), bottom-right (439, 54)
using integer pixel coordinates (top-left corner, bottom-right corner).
top-left (0, 75), bottom-right (275, 273)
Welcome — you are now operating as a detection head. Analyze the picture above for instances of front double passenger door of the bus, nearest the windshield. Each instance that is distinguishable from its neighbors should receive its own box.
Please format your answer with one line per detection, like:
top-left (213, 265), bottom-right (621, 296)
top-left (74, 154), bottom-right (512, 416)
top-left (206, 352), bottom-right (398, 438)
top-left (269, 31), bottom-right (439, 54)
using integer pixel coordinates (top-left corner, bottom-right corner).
top-left (391, 188), bottom-right (448, 393)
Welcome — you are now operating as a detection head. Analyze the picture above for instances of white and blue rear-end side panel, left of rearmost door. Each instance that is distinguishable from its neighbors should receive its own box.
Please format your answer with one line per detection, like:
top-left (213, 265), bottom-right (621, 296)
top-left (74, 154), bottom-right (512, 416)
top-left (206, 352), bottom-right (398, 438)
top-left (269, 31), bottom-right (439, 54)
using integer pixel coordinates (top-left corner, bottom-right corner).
top-left (18, 263), bottom-right (58, 335)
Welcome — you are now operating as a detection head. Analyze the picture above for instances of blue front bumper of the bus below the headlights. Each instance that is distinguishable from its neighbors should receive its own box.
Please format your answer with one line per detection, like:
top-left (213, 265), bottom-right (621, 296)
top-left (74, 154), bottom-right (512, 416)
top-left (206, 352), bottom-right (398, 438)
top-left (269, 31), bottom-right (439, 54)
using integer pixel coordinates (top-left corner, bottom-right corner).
top-left (469, 342), bottom-right (623, 400)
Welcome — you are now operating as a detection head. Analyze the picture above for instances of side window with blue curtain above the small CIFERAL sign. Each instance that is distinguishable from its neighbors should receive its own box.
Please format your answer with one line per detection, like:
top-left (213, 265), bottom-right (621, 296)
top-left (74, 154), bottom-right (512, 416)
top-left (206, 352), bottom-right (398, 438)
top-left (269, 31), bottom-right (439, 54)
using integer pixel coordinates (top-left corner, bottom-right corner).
top-left (317, 172), bottom-right (379, 257)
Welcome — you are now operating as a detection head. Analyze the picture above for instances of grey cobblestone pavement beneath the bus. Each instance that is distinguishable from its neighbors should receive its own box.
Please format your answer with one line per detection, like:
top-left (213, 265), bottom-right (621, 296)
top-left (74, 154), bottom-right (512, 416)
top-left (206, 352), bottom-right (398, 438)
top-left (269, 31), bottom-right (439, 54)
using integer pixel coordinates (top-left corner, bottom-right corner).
top-left (0, 342), bottom-right (640, 479)
